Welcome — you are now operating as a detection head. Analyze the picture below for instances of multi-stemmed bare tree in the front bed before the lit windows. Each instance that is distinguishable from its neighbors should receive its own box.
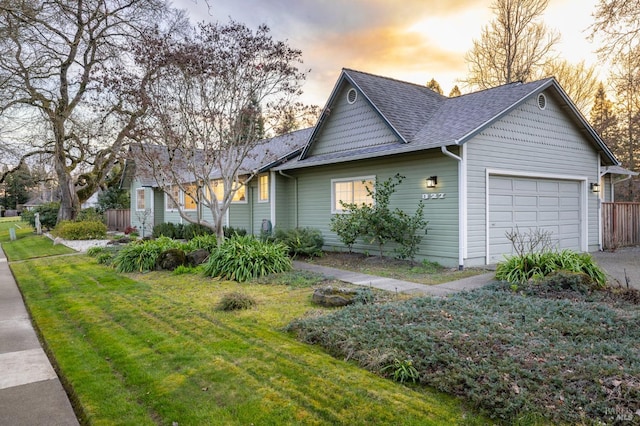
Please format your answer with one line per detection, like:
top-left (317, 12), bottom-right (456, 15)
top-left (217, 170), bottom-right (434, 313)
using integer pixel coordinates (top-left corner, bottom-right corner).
top-left (130, 21), bottom-right (305, 243)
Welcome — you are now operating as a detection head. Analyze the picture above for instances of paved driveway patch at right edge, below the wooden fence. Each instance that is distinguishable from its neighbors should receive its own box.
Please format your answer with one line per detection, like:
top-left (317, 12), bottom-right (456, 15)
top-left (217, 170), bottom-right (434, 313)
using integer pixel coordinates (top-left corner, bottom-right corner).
top-left (591, 247), bottom-right (640, 290)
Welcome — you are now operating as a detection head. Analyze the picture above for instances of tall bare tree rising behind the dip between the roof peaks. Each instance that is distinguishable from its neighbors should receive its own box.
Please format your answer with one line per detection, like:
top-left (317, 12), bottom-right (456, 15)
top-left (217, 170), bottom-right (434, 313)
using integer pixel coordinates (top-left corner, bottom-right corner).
top-left (462, 0), bottom-right (559, 89)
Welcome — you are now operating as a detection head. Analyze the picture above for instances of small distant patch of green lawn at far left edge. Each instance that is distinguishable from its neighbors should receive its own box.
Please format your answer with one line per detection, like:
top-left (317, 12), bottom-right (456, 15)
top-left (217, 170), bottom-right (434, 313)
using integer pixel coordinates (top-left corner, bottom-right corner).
top-left (0, 217), bottom-right (74, 262)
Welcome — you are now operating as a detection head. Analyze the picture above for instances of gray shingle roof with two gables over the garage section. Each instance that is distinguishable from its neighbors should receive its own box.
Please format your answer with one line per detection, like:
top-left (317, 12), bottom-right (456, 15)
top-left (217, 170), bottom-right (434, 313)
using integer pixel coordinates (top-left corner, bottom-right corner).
top-left (282, 68), bottom-right (618, 169)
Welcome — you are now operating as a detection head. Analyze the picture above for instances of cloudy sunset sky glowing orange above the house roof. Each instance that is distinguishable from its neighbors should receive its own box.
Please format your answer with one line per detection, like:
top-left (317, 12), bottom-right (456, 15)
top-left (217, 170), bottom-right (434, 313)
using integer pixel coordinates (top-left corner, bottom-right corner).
top-left (173, 0), bottom-right (597, 106)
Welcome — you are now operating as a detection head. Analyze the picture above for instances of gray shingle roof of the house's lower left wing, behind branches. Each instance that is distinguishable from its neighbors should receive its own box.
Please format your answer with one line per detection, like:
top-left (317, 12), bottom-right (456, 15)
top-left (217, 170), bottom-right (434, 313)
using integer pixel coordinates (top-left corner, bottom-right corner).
top-left (120, 128), bottom-right (313, 188)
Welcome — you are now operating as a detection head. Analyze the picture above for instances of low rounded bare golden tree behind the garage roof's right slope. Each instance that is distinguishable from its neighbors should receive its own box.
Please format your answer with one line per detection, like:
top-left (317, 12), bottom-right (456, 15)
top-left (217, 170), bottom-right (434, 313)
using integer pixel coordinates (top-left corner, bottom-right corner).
top-left (541, 59), bottom-right (599, 116)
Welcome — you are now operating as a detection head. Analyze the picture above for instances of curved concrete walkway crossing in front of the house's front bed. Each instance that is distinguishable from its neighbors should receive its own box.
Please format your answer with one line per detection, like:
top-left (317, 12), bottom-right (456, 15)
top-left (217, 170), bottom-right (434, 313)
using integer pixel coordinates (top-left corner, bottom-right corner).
top-left (293, 261), bottom-right (495, 296)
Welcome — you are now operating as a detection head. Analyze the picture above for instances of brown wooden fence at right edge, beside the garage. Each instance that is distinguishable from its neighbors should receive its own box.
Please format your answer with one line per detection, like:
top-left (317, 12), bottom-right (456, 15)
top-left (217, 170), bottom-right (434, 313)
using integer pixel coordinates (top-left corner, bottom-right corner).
top-left (602, 203), bottom-right (640, 250)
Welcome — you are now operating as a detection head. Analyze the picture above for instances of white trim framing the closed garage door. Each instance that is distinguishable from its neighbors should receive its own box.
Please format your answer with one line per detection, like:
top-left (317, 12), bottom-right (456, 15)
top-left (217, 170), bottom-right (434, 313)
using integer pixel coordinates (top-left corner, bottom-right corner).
top-left (485, 169), bottom-right (589, 265)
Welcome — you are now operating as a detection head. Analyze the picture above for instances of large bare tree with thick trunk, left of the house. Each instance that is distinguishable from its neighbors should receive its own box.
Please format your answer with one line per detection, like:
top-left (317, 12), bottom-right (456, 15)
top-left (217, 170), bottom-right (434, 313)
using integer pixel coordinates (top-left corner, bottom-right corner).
top-left (0, 0), bottom-right (175, 220)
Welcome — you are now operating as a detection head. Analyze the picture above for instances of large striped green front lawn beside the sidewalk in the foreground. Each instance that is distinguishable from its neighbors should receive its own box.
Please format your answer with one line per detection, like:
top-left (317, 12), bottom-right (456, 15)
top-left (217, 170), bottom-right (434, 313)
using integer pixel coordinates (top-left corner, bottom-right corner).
top-left (11, 255), bottom-right (487, 425)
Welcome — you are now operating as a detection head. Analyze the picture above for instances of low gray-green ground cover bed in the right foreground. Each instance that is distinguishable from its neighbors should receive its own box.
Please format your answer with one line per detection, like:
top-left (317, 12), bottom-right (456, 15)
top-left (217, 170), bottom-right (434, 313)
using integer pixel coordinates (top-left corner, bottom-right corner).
top-left (289, 283), bottom-right (640, 424)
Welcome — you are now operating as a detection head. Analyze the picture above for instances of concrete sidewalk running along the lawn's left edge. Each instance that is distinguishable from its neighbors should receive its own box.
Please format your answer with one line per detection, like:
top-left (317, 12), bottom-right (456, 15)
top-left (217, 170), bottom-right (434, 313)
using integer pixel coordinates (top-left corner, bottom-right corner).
top-left (0, 248), bottom-right (79, 426)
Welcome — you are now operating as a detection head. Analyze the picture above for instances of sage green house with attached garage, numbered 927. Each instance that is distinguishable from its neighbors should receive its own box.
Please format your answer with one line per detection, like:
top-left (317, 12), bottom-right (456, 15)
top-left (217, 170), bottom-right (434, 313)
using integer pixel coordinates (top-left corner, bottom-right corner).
top-left (125, 69), bottom-right (632, 268)
